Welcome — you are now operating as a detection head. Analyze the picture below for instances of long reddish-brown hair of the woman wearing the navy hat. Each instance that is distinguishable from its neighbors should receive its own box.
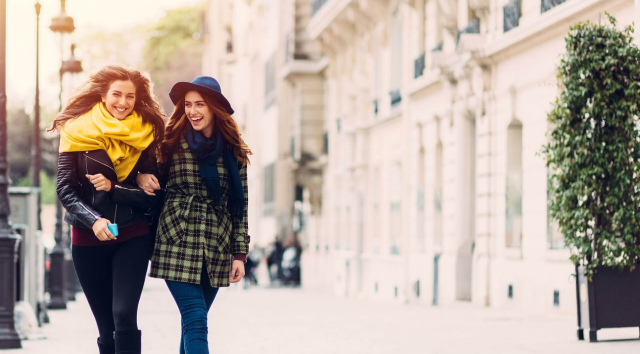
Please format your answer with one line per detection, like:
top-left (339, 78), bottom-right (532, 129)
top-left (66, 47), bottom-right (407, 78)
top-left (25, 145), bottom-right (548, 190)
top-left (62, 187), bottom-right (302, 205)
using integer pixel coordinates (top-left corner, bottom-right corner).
top-left (158, 91), bottom-right (252, 165)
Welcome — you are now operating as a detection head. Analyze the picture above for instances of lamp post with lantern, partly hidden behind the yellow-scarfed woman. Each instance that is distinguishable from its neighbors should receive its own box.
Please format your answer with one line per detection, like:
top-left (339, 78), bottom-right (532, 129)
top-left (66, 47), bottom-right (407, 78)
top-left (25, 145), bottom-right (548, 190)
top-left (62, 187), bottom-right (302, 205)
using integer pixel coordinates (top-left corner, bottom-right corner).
top-left (49, 0), bottom-right (75, 309)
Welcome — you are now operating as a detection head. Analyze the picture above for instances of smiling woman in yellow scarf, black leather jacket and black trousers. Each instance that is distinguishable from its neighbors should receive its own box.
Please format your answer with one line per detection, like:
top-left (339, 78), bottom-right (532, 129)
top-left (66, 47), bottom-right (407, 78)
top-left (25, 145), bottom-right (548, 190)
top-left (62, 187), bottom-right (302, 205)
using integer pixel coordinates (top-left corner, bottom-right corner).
top-left (50, 66), bottom-right (164, 354)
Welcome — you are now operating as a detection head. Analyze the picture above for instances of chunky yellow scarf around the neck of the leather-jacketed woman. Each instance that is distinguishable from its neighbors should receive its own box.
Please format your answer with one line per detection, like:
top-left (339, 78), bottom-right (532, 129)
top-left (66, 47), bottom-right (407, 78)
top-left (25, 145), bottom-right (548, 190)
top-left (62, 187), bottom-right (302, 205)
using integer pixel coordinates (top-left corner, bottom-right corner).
top-left (60, 103), bottom-right (153, 182)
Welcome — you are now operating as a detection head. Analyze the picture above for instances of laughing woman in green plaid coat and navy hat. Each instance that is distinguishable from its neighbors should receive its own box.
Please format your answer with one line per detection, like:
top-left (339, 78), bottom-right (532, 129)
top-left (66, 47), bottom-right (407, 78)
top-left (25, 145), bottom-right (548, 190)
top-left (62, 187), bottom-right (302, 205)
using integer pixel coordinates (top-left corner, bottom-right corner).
top-left (138, 76), bottom-right (251, 354)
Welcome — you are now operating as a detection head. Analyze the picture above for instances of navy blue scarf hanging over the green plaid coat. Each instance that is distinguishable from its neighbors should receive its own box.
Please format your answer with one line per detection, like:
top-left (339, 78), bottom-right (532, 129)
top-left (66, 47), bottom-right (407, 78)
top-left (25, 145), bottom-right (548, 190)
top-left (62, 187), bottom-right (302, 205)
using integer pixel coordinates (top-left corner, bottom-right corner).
top-left (185, 126), bottom-right (245, 220)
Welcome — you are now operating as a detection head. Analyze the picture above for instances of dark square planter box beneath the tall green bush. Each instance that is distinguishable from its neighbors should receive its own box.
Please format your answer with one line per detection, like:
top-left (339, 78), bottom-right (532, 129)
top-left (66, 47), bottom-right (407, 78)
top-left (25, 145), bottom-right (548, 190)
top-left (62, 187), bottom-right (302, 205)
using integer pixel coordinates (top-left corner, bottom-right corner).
top-left (576, 266), bottom-right (640, 342)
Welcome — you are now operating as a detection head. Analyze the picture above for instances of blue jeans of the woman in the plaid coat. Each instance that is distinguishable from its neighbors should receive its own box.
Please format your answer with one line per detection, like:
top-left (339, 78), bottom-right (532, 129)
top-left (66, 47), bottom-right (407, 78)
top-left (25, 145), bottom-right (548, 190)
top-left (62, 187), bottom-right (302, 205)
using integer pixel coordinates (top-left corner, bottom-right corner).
top-left (166, 264), bottom-right (219, 354)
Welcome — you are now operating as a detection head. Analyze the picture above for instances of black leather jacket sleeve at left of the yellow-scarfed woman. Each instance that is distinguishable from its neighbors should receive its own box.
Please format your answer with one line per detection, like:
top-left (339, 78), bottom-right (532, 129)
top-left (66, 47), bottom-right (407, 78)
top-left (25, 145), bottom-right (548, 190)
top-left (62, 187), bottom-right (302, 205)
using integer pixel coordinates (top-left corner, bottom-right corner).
top-left (56, 152), bottom-right (102, 228)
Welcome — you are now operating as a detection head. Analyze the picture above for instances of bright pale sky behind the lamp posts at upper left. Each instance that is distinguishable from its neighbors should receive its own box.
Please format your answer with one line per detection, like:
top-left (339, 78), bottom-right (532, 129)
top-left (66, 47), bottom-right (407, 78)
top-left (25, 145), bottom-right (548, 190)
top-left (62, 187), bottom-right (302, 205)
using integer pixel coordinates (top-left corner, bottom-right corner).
top-left (0, 0), bottom-right (201, 113)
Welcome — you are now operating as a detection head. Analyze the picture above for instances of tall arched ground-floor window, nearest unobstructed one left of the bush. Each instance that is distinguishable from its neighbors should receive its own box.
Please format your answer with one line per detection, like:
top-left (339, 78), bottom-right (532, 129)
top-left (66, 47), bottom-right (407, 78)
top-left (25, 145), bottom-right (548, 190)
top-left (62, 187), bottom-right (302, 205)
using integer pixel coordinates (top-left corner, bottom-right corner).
top-left (505, 120), bottom-right (522, 248)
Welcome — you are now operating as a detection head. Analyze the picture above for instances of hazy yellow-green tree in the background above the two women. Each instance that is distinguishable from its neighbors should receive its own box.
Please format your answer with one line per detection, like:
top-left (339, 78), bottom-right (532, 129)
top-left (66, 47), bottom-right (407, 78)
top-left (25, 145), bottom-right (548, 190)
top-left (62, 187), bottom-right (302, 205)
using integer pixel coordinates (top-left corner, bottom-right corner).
top-left (143, 4), bottom-right (204, 113)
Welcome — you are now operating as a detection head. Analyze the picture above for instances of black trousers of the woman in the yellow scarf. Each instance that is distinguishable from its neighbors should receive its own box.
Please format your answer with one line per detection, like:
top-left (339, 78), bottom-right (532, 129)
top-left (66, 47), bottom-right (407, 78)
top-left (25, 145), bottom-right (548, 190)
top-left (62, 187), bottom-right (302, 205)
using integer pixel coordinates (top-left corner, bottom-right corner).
top-left (71, 235), bottom-right (151, 343)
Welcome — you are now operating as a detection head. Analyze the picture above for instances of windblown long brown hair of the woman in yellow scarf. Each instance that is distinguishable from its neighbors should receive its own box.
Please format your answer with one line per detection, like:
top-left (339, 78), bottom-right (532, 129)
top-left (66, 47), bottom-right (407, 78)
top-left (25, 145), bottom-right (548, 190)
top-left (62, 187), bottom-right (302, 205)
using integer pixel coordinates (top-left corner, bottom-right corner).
top-left (48, 65), bottom-right (164, 153)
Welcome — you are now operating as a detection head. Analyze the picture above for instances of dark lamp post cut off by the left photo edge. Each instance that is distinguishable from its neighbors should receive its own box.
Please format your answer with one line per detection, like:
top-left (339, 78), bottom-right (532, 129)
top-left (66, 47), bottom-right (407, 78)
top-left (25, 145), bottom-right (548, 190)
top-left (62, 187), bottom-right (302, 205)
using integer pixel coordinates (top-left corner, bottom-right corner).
top-left (0, 0), bottom-right (22, 349)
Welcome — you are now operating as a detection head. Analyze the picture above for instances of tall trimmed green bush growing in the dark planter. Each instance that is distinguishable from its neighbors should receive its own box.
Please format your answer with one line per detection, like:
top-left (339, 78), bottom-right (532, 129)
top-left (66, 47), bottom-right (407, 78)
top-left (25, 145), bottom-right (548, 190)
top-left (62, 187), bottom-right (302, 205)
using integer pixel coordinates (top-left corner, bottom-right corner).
top-left (543, 14), bottom-right (640, 277)
